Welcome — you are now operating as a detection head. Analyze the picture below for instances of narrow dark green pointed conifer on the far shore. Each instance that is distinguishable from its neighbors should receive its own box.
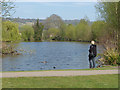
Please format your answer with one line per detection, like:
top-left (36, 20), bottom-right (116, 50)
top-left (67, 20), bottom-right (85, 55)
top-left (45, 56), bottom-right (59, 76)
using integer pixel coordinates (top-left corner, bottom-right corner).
top-left (33, 19), bottom-right (44, 41)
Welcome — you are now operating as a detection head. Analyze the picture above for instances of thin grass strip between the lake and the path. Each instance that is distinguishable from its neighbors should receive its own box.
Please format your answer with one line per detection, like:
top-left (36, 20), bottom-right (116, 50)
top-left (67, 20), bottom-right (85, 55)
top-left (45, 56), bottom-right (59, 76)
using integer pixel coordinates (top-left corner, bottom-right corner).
top-left (2, 66), bottom-right (118, 73)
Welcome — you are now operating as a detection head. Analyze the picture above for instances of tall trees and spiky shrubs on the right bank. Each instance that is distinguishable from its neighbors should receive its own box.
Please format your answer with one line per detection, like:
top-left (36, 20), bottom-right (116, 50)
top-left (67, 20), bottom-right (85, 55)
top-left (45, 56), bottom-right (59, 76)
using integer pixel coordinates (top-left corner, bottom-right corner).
top-left (96, 2), bottom-right (120, 65)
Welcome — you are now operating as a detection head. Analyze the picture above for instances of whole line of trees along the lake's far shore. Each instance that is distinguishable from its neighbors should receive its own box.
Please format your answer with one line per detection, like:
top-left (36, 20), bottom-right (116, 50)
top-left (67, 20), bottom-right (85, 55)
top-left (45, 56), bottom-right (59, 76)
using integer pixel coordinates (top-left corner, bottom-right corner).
top-left (3, 15), bottom-right (105, 41)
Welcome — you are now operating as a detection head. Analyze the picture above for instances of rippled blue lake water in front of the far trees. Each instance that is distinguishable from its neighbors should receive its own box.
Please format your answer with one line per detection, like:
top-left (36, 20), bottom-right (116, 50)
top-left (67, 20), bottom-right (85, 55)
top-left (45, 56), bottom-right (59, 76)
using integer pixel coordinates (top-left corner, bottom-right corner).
top-left (2, 42), bottom-right (101, 71)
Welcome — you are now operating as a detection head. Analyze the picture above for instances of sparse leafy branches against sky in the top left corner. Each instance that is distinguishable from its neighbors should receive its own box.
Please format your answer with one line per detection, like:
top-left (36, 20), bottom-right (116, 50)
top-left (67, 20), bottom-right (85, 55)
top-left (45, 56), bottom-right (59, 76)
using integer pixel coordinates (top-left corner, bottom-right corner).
top-left (0, 0), bottom-right (15, 18)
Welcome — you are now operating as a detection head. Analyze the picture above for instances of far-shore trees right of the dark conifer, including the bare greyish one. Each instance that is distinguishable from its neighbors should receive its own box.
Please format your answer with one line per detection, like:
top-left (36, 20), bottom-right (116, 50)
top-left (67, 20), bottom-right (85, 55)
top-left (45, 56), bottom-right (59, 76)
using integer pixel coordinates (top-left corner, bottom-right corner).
top-left (43, 16), bottom-right (107, 41)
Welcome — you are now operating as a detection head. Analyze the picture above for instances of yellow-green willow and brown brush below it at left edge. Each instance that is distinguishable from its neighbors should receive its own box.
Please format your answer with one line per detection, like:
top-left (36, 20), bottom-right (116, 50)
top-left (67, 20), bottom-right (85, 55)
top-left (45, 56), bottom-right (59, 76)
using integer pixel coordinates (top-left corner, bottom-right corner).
top-left (0, 21), bottom-right (21, 55)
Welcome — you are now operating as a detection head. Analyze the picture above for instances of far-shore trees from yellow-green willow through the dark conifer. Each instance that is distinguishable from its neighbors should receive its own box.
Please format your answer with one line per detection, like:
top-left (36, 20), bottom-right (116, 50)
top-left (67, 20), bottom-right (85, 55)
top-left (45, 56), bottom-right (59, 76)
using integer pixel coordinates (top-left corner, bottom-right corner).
top-left (2, 20), bottom-right (44, 42)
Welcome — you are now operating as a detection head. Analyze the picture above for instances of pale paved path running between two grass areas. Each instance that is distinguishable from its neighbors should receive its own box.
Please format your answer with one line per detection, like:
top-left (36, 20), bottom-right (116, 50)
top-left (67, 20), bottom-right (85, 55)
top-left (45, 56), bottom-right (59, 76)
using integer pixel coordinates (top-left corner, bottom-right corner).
top-left (0, 70), bottom-right (118, 78)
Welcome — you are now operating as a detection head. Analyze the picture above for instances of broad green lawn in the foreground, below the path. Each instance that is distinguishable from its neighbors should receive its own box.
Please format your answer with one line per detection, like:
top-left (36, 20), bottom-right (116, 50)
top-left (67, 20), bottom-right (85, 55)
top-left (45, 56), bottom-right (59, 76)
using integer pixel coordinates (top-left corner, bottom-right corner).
top-left (2, 74), bottom-right (118, 88)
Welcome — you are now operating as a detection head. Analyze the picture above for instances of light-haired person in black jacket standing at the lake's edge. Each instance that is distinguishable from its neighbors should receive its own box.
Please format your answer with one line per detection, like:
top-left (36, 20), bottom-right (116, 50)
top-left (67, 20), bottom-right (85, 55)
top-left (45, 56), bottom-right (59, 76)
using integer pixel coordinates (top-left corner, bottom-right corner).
top-left (89, 41), bottom-right (97, 68)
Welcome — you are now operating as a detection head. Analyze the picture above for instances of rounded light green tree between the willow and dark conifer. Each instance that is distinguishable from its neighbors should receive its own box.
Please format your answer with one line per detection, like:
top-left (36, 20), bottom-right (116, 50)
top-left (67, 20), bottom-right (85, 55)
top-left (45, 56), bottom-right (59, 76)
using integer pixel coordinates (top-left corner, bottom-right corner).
top-left (20, 25), bottom-right (34, 41)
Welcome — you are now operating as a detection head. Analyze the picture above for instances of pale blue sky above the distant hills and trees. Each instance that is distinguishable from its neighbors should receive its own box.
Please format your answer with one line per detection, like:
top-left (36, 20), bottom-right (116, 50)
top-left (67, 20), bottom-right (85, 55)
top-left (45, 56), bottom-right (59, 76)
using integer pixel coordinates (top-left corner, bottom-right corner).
top-left (13, 2), bottom-right (97, 21)
